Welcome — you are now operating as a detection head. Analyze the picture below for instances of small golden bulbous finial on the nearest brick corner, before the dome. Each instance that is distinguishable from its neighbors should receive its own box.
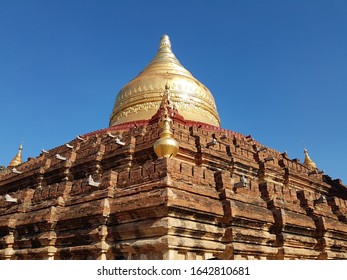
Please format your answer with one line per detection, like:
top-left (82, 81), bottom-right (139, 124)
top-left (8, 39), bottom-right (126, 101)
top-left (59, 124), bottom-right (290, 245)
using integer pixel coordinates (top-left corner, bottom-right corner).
top-left (153, 85), bottom-right (179, 158)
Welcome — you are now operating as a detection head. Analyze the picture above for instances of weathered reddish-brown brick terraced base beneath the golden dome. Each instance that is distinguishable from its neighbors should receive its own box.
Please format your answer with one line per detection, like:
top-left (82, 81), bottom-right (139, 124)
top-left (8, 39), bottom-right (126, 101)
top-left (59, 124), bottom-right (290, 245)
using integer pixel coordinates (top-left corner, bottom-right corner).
top-left (0, 123), bottom-right (347, 259)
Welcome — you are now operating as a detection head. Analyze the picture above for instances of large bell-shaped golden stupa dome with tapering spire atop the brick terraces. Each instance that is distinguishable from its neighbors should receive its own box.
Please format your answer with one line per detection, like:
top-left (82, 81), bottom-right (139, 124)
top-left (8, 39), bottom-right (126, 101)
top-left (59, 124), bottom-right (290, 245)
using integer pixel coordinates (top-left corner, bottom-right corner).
top-left (110, 35), bottom-right (220, 126)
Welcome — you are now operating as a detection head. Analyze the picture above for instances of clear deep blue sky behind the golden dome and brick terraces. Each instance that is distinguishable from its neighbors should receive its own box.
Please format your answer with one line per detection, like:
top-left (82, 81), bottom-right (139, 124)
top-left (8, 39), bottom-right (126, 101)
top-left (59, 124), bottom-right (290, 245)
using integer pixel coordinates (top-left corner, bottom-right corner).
top-left (0, 0), bottom-right (347, 184)
